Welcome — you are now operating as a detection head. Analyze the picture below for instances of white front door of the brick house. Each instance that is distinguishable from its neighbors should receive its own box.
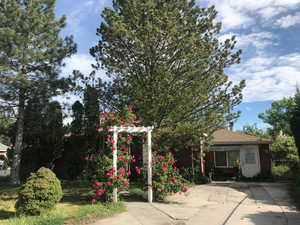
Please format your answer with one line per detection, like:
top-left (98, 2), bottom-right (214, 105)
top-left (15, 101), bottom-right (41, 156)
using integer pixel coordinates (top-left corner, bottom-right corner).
top-left (240, 145), bottom-right (260, 177)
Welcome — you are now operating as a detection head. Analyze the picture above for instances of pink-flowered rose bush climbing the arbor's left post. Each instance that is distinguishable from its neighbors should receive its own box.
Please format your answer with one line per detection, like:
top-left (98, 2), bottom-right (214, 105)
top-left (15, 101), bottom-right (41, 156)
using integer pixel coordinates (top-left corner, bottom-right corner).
top-left (85, 106), bottom-right (137, 203)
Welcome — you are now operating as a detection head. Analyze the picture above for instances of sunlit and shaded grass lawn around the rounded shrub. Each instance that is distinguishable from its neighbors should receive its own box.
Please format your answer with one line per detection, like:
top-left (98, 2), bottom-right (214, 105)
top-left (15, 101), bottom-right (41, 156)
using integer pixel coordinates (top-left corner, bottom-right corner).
top-left (0, 177), bottom-right (125, 225)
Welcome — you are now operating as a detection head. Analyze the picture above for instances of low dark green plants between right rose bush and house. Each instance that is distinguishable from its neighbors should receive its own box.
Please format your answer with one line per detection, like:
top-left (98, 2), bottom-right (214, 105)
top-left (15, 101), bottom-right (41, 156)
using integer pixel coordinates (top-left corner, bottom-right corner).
top-left (179, 168), bottom-right (210, 184)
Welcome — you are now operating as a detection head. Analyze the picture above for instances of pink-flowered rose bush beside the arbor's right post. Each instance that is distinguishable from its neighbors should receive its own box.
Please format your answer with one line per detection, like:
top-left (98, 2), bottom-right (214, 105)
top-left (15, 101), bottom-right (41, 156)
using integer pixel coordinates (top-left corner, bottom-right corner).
top-left (141, 152), bottom-right (188, 199)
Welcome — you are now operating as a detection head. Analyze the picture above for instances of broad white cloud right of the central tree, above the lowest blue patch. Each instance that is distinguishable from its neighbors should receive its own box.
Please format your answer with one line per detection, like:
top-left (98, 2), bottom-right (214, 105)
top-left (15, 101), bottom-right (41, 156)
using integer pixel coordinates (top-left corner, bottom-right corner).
top-left (230, 53), bottom-right (300, 102)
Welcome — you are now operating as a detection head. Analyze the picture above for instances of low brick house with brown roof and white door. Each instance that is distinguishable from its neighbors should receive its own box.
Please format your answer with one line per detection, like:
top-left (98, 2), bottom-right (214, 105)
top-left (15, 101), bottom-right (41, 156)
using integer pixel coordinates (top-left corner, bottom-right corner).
top-left (205, 129), bottom-right (272, 178)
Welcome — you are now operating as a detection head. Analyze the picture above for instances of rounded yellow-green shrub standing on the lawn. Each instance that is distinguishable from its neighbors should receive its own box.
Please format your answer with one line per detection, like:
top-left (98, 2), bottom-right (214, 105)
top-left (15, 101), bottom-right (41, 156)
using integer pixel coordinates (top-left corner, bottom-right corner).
top-left (15, 167), bottom-right (63, 215)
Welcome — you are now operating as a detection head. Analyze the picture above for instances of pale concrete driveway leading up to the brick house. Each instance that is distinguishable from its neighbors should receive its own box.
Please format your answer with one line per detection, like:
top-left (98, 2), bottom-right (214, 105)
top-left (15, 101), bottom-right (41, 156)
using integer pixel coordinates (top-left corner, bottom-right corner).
top-left (93, 182), bottom-right (300, 225)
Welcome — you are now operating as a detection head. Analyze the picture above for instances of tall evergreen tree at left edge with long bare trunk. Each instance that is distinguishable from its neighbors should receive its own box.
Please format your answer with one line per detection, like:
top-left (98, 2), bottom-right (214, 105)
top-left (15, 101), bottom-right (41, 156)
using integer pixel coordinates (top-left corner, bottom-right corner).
top-left (0, 0), bottom-right (76, 184)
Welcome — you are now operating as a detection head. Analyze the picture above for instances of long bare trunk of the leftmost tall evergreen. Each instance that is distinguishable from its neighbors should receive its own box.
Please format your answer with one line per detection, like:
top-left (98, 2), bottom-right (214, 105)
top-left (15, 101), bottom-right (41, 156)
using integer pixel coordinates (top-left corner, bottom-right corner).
top-left (10, 90), bottom-right (25, 185)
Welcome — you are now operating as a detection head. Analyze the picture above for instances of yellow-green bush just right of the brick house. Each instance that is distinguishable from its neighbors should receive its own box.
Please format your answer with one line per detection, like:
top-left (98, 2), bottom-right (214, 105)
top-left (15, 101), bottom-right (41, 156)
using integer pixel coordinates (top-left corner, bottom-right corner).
top-left (270, 136), bottom-right (299, 161)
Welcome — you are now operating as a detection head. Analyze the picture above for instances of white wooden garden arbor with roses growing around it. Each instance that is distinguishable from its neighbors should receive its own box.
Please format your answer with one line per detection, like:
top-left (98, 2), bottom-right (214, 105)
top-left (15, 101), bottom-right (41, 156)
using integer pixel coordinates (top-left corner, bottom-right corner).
top-left (109, 126), bottom-right (153, 203)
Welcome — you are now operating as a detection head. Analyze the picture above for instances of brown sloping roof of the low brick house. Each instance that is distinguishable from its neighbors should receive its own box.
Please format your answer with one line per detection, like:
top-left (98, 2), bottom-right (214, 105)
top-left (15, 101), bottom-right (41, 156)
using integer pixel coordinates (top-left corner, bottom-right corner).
top-left (213, 129), bottom-right (272, 145)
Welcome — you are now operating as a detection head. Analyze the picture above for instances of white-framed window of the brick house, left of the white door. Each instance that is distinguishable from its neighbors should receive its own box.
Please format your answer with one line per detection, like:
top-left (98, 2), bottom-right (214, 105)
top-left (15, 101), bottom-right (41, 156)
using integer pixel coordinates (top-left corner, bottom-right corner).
top-left (215, 151), bottom-right (240, 167)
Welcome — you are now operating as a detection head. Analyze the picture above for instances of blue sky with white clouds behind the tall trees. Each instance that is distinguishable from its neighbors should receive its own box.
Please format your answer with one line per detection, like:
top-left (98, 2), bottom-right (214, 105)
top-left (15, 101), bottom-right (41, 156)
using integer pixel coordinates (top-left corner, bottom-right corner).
top-left (56, 0), bottom-right (300, 130)
